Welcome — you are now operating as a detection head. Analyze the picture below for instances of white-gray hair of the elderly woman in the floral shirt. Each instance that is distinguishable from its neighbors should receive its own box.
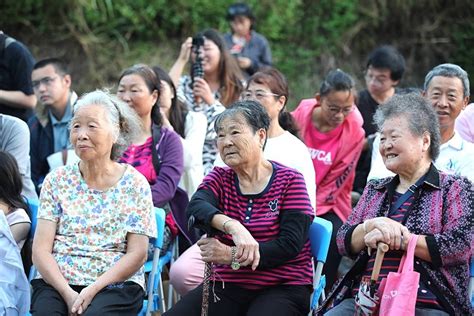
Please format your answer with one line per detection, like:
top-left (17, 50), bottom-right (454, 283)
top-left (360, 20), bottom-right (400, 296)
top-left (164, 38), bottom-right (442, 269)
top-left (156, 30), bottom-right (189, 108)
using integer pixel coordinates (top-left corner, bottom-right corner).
top-left (74, 90), bottom-right (142, 160)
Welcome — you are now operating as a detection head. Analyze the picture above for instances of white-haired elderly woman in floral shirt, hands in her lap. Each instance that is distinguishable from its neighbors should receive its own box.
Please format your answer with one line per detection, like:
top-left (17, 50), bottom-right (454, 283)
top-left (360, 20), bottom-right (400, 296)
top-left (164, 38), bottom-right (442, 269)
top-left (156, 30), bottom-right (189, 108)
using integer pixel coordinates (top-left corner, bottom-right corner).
top-left (31, 91), bottom-right (156, 315)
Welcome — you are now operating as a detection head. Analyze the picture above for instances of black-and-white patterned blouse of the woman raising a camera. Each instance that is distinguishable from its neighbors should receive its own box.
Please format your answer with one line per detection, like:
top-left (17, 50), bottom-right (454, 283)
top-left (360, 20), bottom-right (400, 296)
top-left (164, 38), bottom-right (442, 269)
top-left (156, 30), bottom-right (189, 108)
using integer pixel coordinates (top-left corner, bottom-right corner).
top-left (177, 76), bottom-right (225, 175)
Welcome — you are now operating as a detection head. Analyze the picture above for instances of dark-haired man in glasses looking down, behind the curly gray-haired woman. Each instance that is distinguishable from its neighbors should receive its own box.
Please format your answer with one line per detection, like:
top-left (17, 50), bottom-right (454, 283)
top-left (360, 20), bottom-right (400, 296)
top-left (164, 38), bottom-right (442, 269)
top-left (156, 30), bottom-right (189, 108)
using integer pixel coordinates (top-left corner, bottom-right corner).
top-left (353, 45), bottom-right (405, 194)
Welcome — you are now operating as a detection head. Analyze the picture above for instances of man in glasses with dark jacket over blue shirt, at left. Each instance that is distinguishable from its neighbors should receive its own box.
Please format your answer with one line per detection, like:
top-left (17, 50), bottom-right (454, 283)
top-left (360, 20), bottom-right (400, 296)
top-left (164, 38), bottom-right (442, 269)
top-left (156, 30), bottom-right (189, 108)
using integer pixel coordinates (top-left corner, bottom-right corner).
top-left (28, 58), bottom-right (77, 192)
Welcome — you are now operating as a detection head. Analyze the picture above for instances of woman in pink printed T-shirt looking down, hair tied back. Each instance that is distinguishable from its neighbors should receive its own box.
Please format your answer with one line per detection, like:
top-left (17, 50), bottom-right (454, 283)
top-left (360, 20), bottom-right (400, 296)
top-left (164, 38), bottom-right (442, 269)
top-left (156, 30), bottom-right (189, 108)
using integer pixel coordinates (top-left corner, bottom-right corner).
top-left (292, 69), bottom-right (364, 288)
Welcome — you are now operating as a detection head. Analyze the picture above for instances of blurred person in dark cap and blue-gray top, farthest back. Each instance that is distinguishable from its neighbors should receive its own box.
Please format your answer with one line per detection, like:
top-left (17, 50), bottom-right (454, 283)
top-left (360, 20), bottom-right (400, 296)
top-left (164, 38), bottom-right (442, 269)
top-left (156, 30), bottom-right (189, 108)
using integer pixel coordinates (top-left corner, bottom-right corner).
top-left (224, 3), bottom-right (272, 76)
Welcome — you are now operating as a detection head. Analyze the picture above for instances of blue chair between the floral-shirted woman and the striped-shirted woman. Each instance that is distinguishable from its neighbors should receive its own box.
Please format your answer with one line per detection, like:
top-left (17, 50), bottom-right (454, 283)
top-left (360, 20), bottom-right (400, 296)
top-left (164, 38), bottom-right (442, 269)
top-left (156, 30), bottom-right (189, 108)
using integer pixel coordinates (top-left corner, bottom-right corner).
top-left (138, 207), bottom-right (171, 316)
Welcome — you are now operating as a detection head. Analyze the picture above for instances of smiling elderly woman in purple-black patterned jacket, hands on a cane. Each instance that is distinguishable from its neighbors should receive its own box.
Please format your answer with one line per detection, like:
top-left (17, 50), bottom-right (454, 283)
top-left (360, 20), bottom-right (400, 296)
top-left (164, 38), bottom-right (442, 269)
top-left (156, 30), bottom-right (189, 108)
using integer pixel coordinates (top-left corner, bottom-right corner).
top-left (323, 94), bottom-right (474, 315)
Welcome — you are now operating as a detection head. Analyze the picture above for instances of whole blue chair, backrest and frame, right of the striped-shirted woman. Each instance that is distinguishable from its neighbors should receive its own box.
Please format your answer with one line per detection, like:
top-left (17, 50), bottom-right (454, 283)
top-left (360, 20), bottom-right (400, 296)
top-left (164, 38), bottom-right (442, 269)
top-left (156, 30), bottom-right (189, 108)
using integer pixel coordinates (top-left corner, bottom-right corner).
top-left (309, 217), bottom-right (332, 310)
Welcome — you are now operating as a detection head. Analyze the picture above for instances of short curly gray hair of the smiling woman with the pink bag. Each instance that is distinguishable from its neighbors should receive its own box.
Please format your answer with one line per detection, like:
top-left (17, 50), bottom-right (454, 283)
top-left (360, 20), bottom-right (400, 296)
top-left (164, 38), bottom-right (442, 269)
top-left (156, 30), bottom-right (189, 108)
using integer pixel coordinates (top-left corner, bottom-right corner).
top-left (374, 93), bottom-right (441, 160)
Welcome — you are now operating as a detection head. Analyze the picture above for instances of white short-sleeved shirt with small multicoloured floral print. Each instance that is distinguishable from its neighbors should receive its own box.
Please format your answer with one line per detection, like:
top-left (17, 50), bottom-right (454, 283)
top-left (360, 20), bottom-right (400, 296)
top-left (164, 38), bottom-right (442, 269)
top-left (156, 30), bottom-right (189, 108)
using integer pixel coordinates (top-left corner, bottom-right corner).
top-left (38, 164), bottom-right (156, 287)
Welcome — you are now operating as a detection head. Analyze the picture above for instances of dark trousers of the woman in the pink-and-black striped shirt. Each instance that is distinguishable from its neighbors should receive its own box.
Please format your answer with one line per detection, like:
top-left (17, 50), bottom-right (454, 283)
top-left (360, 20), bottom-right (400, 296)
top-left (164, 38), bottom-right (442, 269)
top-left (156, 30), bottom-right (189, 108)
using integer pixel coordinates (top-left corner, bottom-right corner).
top-left (163, 281), bottom-right (311, 316)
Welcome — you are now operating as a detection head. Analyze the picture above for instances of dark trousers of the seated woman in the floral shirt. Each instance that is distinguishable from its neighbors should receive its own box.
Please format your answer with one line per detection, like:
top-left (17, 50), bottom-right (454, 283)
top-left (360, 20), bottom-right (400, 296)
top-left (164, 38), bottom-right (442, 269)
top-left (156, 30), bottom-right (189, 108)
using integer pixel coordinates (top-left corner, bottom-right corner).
top-left (30, 279), bottom-right (145, 316)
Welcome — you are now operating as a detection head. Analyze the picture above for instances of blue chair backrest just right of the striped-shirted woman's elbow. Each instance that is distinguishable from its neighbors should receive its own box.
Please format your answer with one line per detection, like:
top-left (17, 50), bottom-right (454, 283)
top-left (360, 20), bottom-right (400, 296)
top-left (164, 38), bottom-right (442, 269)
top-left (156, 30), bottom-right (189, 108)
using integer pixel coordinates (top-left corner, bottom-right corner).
top-left (309, 217), bottom-right (332, 263)
